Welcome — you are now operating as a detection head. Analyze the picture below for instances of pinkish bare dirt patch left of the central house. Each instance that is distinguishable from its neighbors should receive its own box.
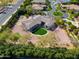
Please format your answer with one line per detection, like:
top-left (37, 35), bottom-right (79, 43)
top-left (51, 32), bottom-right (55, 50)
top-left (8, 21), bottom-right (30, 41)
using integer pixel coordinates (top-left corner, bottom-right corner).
top-left (12, 16), bottom-right (29, 35)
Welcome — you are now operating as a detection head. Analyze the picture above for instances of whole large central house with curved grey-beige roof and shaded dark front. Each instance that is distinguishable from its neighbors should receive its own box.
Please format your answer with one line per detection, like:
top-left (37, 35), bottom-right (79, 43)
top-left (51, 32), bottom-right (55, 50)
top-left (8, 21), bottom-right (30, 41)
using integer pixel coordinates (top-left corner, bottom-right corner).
top-left (22, 15), bottom-right (55, 31)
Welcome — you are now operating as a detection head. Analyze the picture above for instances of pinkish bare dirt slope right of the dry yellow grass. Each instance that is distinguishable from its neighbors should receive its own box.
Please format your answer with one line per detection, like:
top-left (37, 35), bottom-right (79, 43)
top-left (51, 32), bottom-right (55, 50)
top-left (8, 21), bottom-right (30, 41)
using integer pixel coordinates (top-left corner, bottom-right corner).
top-left (54, 27), bottom-right (73, 48)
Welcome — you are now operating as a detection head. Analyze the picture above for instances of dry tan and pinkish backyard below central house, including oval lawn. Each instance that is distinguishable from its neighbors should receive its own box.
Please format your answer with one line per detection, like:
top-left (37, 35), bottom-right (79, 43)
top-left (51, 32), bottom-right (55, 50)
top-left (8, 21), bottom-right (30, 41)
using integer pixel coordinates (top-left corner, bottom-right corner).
top-left (12, 16), bottom-right (73, 48)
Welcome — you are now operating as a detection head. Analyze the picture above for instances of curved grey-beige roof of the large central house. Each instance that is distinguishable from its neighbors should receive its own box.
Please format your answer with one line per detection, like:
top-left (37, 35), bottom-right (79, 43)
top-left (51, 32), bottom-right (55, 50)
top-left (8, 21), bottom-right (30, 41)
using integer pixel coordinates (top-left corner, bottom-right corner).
top-left (23, 15), bottom-right (54, 30)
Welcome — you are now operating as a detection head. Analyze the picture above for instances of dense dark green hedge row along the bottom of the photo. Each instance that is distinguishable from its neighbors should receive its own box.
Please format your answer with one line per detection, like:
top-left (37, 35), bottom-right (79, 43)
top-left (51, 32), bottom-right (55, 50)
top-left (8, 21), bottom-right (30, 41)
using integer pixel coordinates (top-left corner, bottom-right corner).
top-left (0, 44), bottom-right (79, 59)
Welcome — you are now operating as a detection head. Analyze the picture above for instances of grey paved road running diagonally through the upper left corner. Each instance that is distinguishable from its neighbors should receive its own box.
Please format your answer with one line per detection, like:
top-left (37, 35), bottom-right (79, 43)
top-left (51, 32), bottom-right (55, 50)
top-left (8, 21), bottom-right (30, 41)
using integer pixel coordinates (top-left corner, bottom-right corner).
top-left (0, 0), bottom-right (24, 26)
